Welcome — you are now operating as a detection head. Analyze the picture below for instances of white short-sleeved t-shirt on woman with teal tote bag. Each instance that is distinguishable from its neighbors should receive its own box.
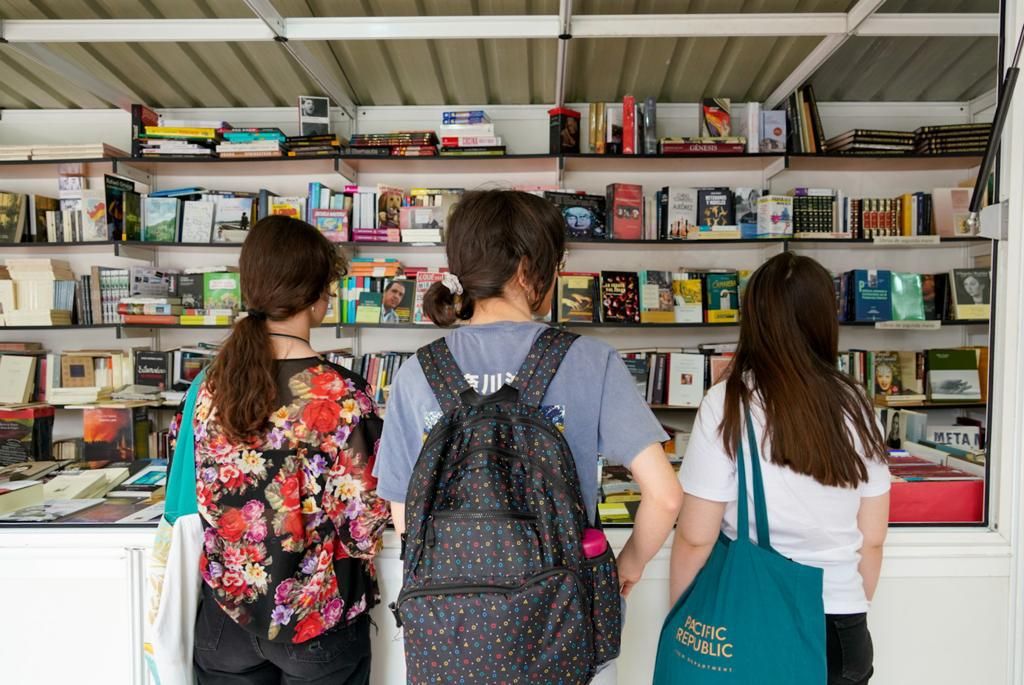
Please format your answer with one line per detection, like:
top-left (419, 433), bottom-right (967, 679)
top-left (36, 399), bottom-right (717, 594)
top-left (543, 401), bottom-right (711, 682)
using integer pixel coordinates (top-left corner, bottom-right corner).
top-left (679, 383), bottom-right (890, 613)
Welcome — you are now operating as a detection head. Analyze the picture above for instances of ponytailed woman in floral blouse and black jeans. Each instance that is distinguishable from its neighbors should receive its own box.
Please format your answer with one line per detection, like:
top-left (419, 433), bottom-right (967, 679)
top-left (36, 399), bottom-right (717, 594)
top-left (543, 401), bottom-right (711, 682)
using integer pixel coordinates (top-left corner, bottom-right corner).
top-left (184, 216), bottom-right (388, 685)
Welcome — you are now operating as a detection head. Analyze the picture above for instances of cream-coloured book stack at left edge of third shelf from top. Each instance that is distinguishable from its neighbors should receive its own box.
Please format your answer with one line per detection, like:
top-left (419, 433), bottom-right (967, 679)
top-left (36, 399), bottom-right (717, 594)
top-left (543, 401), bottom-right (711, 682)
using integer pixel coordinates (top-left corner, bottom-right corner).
top-left (4, 258), bottom-right (77, 326)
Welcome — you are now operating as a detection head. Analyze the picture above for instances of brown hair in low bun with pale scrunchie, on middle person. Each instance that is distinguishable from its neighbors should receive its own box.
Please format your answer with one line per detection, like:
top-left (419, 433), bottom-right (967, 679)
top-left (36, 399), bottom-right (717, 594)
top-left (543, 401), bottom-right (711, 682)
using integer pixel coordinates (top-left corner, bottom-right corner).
top-left (423, 190), bottom-right (565, 326)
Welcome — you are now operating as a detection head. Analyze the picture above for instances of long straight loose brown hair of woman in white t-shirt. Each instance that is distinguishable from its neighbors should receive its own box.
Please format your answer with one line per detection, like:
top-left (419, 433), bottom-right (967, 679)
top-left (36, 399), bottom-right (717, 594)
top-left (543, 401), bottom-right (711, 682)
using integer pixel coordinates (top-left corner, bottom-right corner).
top-left (719, 252), bottom-right (885, 487)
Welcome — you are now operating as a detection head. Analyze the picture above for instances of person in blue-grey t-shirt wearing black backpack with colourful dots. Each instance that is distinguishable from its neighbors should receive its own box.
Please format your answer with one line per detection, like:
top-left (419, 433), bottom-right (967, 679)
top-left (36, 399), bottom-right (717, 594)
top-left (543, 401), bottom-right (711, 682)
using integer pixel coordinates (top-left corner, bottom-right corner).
top-left (375, 190), bottom-right (681, 685)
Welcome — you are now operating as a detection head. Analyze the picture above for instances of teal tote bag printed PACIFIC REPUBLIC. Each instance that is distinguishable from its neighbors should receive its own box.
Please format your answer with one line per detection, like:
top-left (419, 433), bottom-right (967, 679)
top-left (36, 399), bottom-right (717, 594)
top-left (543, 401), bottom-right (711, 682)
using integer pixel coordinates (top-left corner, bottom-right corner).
top-left (654, 410), bottom-right (826, 685)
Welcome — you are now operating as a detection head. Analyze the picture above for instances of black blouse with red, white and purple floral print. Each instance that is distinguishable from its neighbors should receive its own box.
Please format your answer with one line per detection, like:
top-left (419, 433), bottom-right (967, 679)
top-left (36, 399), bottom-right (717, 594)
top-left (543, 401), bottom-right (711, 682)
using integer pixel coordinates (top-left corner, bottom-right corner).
top-left (180, 358), bottom-right (388, 643)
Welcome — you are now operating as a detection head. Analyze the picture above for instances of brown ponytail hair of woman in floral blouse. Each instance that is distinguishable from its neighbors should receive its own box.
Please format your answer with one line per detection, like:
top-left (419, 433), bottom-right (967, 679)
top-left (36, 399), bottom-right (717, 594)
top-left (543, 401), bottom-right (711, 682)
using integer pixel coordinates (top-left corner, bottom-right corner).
top-left (206, 216), bottom-right (346, 440)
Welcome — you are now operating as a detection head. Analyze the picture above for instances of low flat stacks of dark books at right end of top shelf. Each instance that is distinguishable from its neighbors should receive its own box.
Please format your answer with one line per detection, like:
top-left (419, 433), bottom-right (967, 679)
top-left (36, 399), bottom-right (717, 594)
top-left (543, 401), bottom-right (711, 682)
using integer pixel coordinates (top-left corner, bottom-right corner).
top-left (825, 123), bottom-right (992, 155)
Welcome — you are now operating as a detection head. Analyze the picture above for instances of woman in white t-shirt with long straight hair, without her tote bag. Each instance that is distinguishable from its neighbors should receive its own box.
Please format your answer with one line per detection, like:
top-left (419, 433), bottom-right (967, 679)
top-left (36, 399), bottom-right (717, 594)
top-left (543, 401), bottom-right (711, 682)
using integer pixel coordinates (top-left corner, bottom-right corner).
top-left (671, 253), bottom-right (889, 685)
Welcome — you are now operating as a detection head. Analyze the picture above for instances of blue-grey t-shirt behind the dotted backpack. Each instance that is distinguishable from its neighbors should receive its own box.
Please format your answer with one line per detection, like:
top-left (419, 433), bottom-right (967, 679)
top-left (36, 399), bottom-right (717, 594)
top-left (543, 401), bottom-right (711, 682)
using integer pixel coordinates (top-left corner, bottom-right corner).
top-left (374, 322), bottom-right (668, 519)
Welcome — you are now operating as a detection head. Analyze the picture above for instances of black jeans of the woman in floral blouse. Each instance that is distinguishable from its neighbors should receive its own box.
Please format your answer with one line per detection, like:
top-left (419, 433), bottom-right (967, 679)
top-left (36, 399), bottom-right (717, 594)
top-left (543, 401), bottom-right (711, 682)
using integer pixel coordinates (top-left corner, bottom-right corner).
top-left (193, 600), bottom-right (370, 685)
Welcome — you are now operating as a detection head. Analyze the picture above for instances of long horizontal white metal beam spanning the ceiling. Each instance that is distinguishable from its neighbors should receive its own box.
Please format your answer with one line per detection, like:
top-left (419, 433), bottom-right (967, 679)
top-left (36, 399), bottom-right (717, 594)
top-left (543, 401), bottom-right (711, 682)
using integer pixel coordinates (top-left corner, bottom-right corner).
top-left (4, 13), bottom-right (999, 43)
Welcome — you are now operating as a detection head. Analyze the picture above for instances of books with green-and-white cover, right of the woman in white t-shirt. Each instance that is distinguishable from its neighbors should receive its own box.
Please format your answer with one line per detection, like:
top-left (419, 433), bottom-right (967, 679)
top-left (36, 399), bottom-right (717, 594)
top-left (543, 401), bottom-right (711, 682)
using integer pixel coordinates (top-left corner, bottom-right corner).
top-left (839, 347), bottom-right (988, 406)
